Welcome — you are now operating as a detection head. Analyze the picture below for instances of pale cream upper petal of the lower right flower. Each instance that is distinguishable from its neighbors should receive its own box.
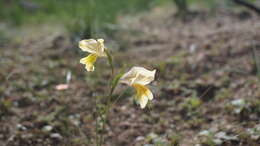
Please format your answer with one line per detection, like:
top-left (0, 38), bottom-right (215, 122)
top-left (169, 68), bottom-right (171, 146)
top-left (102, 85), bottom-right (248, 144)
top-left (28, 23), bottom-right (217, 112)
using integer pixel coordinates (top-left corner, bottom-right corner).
top-left (121, 67), bottom-right (156, 85)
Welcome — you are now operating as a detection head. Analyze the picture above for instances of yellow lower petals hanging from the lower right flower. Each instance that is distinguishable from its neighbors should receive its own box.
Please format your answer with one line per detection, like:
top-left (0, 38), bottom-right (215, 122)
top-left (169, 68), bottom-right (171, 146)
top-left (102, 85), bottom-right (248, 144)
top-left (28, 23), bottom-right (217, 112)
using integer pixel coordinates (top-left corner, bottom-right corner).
top-left (133, 84), bottom-right (153, 108)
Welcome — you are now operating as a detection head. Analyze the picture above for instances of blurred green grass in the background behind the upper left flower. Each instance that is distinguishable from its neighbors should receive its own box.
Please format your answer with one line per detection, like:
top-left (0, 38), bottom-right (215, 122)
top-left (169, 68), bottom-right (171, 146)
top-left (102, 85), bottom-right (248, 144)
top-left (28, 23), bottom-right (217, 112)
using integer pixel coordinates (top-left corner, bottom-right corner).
top-left (0, 0), bottom-right (159, 37)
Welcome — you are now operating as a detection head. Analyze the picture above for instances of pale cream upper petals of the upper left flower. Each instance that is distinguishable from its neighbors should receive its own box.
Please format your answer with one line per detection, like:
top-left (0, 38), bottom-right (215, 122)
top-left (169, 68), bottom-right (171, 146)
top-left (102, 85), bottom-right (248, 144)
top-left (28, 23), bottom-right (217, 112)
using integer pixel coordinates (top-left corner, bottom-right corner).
top-left (79, 39), bottom-right (106, 56)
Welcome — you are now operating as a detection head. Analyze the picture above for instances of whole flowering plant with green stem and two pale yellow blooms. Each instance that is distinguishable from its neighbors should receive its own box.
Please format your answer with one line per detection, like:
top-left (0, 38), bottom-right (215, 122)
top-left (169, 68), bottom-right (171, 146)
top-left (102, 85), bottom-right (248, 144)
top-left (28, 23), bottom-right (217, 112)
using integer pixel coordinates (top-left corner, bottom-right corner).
top-left (79, 39), bottom-right (156, 146)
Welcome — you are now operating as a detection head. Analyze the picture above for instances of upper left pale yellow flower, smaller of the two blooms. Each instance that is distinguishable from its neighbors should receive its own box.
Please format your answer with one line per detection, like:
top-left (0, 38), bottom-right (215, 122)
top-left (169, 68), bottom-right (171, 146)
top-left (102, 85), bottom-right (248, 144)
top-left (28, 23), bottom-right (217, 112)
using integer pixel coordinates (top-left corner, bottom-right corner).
top-left (79, 39), bottom-right (106, 71)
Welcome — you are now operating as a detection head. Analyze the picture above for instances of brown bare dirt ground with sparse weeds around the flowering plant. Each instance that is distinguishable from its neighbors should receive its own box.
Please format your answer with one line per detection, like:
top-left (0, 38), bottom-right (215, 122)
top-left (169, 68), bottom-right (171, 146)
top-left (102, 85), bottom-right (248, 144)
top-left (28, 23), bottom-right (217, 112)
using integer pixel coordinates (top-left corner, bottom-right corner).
top-left (0, 8), bottom-right (260, 146)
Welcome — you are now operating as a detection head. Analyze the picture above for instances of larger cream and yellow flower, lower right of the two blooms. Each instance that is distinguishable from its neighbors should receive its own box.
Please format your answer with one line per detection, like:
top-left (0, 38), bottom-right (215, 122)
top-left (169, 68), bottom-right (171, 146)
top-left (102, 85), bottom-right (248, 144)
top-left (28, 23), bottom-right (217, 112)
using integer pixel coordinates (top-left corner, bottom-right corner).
top-left (120, 67), bottom-right (156, 108)
